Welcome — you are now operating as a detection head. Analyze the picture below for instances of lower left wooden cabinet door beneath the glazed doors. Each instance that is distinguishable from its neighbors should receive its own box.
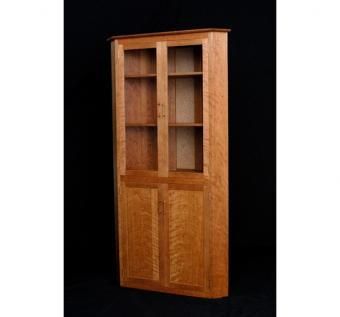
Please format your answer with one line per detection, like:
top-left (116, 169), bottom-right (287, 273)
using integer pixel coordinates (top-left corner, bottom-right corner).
top-left (120, 183), bottom-right (160, 284)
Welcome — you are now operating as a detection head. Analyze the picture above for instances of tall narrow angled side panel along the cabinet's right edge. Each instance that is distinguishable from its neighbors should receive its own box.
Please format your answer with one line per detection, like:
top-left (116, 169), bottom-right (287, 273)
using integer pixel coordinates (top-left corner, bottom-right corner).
top-left (209, 32), bottom-right (228, 297)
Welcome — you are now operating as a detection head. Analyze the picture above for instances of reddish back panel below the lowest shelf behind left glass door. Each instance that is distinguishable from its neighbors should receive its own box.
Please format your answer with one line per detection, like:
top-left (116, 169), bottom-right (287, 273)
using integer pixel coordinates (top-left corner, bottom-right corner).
top-left (126, 127), bottom-right (157, 170)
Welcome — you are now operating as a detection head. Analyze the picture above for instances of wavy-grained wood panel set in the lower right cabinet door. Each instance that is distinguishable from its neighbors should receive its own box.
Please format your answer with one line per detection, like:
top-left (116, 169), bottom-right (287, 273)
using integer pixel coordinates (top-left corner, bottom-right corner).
top-left (168, 189), bottom-right (205, 288)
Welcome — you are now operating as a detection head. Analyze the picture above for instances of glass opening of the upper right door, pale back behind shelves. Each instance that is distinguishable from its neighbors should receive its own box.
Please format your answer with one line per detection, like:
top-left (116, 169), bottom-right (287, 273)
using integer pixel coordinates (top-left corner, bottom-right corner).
top-left (168, 45), bottom-right (203, 172)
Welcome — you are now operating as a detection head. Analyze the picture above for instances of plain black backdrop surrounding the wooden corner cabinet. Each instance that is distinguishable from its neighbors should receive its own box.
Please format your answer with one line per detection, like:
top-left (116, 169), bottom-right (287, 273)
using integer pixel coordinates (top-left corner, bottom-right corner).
top-left (65, 0), bottom-right (276, 316)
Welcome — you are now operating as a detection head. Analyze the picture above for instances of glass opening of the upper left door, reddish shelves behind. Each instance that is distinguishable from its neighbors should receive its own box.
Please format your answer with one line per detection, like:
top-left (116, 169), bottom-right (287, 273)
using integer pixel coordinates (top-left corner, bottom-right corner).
top-left (124, 48), bottom-right (158, 170)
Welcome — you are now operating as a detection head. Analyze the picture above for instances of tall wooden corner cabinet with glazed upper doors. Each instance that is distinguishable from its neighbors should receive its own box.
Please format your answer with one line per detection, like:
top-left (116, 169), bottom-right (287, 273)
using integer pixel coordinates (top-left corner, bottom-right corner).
top-left (109, 29), bottom-right (229, 298)
